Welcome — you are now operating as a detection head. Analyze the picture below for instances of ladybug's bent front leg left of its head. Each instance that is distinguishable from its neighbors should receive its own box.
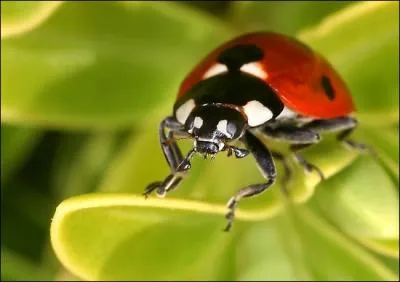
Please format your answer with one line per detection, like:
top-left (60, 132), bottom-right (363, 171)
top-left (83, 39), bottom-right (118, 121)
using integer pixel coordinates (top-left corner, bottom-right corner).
top-left (143, 117), bottom-right (194, 198)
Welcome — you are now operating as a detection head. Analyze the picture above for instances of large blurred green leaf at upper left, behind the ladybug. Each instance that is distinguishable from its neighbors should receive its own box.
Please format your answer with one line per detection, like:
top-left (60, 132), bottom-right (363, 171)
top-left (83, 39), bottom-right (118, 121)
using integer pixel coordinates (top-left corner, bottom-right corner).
top-left (1, 2), bottom-right (230, 128)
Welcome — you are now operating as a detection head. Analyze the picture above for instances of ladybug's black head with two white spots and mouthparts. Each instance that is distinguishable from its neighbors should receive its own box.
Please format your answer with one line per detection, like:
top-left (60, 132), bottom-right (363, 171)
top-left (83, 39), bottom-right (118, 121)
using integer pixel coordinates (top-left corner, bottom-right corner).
top-left (185, 104), bottom-right (247, 155)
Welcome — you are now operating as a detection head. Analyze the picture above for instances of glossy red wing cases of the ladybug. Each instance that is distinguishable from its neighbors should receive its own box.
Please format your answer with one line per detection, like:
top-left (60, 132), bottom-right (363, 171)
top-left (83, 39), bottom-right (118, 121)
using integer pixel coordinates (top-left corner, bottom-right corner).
top-left (177, 32), bottom-right (355, 119)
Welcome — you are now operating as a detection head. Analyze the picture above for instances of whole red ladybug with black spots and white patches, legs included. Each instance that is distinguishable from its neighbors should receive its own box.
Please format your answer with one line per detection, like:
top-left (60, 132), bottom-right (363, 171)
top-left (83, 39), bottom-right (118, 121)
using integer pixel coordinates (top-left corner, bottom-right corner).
top-left (143, 32), bottom-right (366, 231)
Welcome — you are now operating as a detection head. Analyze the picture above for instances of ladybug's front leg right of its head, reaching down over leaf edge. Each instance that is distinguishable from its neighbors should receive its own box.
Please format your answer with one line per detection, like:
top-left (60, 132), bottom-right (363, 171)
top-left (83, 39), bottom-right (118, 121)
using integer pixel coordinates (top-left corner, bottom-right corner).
top-left (224, 131), bottom-right (276, 231)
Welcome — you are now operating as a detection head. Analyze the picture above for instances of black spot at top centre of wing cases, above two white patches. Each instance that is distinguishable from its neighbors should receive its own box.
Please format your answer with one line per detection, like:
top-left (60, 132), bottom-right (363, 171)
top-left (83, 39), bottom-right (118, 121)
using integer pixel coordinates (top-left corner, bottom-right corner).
top-left (217, 44), bottom-right (265, 70)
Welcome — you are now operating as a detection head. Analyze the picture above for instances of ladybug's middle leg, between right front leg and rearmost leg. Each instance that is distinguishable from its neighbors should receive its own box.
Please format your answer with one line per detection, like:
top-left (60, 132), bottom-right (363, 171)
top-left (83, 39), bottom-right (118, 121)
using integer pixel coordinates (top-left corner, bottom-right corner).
top-left (262, 125), bottom-right (325, 180)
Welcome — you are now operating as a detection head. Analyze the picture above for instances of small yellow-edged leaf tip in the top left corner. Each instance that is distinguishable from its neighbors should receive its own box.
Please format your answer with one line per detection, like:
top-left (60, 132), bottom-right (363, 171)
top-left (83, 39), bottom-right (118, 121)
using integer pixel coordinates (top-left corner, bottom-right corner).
top-left (1, 1), bottom-right (62, 39)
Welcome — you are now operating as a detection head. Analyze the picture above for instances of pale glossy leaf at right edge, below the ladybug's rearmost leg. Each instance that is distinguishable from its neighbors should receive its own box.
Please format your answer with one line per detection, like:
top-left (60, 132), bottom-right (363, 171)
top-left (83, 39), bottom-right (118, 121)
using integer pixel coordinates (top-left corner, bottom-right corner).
top-left (313, 154), bottom-right (399, 253)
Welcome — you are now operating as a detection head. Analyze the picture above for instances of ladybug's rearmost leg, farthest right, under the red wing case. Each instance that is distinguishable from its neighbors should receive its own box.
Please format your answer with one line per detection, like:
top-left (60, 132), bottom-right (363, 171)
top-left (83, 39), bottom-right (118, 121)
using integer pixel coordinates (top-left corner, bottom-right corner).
top-left (304, 117), bottom-right (371, 152)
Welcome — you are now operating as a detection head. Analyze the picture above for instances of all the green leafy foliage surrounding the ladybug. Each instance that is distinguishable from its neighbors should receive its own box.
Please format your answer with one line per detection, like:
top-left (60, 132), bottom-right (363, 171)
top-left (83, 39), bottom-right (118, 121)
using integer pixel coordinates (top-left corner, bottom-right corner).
top-left (1, 1), bottom-right (399, 281)
